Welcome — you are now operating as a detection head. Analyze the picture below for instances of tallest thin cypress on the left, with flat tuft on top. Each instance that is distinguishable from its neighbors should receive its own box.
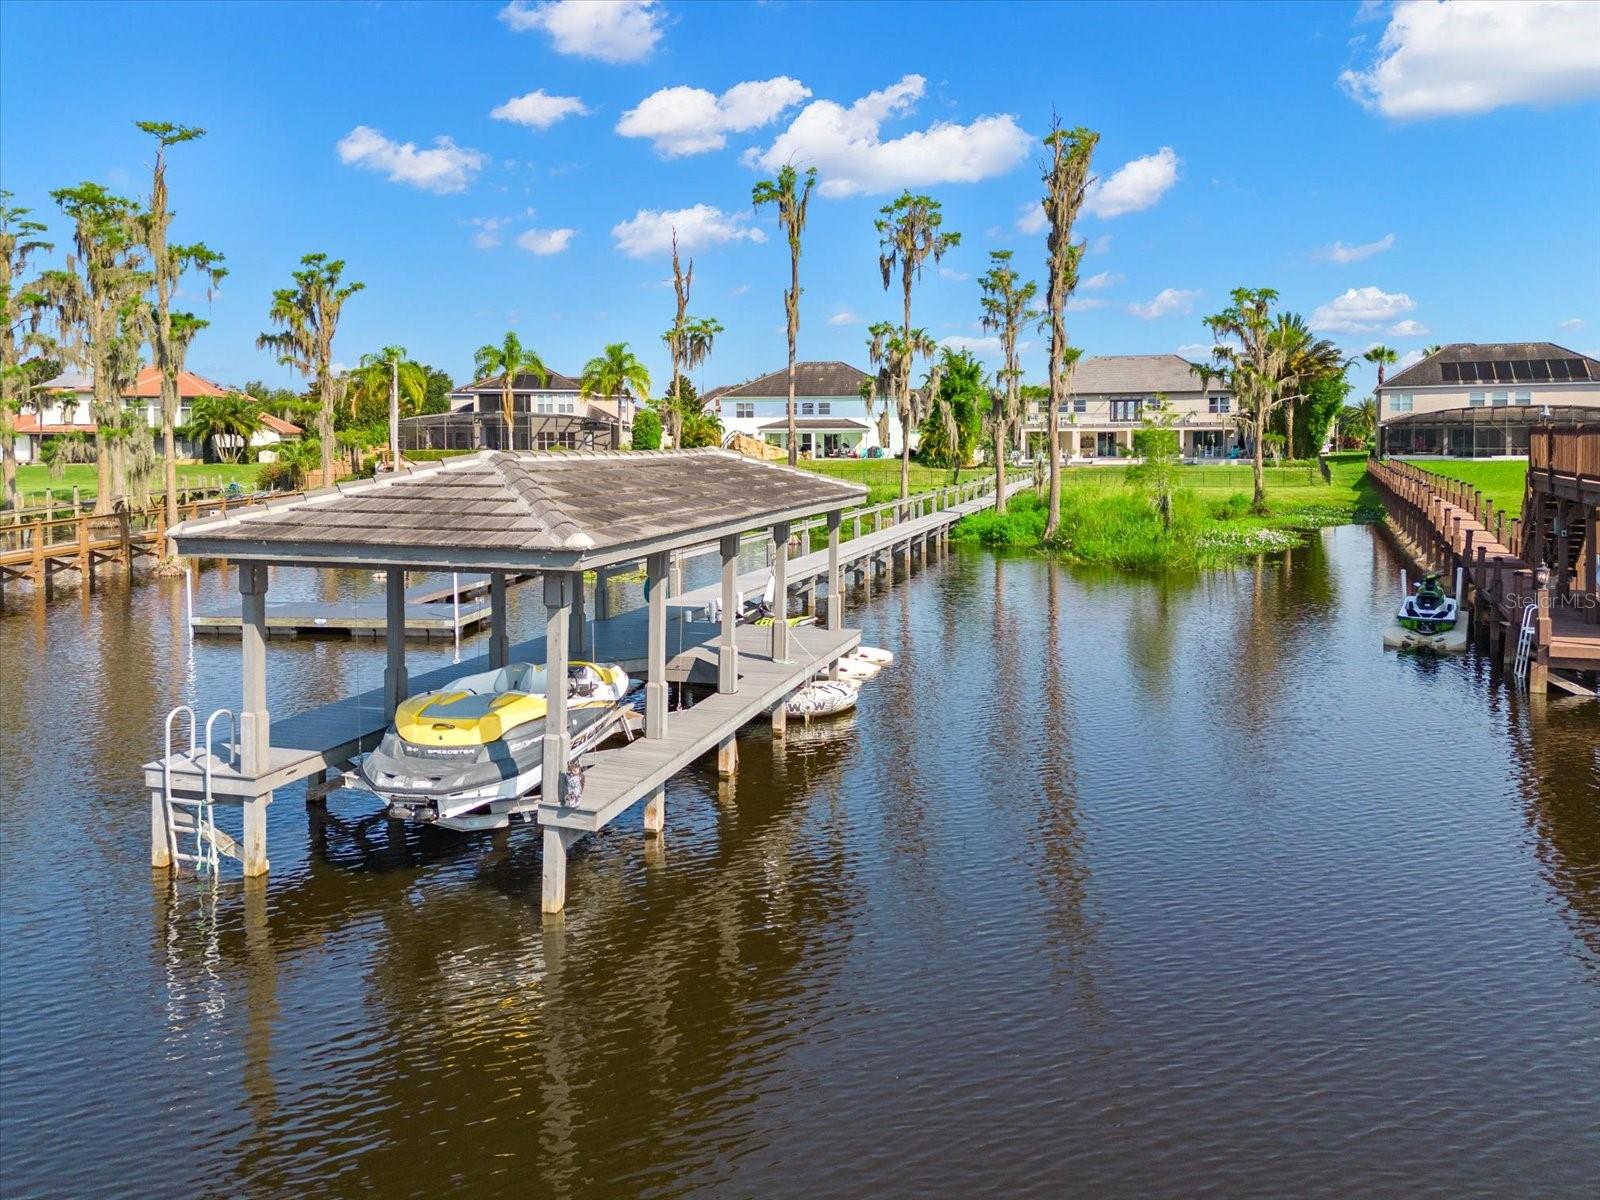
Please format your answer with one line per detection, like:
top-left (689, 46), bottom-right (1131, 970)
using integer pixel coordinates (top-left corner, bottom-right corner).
top-left (134, 122), bottom-right (227, 560)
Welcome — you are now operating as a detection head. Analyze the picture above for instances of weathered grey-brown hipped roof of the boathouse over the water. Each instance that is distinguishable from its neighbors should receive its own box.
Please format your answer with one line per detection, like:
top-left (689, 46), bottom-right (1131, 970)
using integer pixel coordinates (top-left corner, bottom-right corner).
top-left (171, 450), bottom-right (866, 570)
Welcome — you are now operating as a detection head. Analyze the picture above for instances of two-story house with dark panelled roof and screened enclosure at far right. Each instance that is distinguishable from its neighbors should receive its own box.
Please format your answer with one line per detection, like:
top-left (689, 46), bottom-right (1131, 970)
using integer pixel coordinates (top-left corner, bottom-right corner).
top-left (1378, 342), bottom-right (1600, 458)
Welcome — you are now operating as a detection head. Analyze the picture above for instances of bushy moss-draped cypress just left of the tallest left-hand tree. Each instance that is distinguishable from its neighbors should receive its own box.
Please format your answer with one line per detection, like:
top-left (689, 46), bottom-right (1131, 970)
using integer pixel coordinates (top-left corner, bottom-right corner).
top-left (40, 184), bottom-right (149, 515)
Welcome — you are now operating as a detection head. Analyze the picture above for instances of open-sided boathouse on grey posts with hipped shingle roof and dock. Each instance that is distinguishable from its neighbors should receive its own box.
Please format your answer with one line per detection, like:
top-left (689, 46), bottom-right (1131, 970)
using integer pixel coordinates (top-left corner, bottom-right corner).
top-left (159, 450), bottom-right (866, 912)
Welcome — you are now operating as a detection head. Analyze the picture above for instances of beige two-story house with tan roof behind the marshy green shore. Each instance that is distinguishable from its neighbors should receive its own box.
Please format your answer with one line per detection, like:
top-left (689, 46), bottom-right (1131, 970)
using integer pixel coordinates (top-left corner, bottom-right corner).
top-left (1029, 354), bottom-right (1246, 462)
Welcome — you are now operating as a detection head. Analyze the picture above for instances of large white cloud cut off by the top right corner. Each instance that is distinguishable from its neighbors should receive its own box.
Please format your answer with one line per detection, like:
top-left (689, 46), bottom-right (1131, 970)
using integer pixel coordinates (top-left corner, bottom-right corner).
top-left (1339, 0), bottom-right (1600, 118)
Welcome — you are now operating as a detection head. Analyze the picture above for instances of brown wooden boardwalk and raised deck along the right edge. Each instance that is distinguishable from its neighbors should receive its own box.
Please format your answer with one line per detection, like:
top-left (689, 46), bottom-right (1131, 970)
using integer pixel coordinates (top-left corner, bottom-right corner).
top-left (1368, 426), bottom-right (1600, 694)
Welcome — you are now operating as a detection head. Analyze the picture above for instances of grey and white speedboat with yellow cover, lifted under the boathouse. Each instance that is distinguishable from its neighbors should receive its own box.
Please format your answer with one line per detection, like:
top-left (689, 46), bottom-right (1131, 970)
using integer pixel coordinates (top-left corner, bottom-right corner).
top-left (360, 662), bottom-right (629, 829)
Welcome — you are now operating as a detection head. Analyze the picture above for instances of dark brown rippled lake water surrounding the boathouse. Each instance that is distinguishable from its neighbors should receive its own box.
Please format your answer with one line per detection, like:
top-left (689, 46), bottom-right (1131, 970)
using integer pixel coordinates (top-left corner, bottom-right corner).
top-left (0, 526), bottom-right (1600, 1197)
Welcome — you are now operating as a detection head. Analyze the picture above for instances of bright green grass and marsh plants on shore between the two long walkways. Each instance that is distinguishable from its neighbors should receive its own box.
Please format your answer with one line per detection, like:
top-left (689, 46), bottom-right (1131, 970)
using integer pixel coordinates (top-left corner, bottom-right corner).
top-left (950, 451), bottom-right (1382, 571)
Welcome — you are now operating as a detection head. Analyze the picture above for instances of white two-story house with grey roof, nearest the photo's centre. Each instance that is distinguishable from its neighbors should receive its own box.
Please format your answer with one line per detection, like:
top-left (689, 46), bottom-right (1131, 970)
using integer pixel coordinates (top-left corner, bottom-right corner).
top-left (709, 360), bottom-right (917, 458)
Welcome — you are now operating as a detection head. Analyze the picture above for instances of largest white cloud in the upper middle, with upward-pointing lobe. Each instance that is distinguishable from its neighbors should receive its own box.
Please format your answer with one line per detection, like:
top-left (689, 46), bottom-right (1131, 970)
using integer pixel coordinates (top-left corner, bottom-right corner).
top-left (744, 75), bottom-right (1032, 197)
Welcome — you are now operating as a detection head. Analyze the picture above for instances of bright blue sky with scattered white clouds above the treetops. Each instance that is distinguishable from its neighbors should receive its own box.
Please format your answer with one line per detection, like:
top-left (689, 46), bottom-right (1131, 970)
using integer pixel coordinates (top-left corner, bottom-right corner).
top-left (0, 0), bottom-right (1600, 404)
